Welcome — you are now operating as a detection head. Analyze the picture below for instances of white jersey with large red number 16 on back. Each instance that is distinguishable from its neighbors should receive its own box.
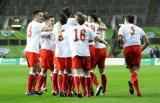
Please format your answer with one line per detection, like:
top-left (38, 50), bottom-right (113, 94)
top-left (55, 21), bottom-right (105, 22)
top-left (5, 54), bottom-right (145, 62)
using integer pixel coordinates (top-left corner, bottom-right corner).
top-left (67, 25), bottom-right (96, 57)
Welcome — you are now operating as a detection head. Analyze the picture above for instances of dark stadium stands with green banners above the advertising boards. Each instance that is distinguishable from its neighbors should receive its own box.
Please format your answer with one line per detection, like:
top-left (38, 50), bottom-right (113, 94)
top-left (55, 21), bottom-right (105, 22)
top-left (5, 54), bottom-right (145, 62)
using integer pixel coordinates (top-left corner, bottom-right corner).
top-left (0, 0), bottom-right (160, 58)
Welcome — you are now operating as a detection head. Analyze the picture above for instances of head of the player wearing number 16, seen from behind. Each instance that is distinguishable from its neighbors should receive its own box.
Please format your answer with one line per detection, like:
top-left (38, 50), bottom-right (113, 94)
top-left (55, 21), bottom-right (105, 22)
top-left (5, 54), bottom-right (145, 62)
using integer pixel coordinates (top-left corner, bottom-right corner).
top-left (75, 12), bottom-right (85, 25)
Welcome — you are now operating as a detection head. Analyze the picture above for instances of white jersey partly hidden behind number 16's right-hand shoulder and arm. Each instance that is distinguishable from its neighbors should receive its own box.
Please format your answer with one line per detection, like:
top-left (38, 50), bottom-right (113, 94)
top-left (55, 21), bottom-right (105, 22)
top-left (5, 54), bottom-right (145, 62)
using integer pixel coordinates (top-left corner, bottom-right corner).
top-left (84, 22), bottom-right (99, 45)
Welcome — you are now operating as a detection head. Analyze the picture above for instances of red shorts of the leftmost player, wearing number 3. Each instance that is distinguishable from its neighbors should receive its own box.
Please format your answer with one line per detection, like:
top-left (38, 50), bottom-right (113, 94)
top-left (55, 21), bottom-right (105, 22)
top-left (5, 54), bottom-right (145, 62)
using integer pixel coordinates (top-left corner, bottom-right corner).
top-left (26, 52), bottom-right (39, 67)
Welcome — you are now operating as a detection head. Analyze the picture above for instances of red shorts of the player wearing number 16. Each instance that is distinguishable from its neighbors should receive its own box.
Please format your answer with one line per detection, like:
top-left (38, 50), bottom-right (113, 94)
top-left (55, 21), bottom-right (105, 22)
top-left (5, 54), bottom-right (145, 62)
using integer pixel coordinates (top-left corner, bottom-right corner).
top-left (72, 56), bottom-right (91, 70)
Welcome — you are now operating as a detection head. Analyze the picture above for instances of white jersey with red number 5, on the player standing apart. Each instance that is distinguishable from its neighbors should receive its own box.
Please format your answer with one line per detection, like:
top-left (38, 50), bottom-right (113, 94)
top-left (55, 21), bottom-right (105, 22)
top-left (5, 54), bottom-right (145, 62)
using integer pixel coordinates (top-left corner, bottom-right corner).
top-left (118, 24), bottom-right (145, 47)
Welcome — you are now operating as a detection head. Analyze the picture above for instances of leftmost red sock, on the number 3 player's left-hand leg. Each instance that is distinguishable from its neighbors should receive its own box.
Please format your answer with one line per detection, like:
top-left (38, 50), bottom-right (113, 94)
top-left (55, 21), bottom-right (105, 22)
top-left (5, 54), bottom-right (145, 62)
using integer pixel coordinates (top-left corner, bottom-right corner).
top-left (27, 74), bottom-right (35, 93)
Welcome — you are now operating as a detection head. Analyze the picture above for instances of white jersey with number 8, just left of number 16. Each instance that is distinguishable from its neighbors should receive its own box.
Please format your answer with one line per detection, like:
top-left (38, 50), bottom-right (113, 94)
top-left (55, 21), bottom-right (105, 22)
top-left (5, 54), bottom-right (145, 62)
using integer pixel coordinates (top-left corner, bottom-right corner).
top-left (54, 24), bottom-right (71, 58)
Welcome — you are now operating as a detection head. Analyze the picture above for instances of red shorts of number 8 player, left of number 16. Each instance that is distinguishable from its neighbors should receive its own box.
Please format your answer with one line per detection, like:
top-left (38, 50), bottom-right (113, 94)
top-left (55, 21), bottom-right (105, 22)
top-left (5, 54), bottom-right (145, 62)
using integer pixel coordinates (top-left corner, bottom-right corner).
top-left (54, 57), bottom-right (72, 70)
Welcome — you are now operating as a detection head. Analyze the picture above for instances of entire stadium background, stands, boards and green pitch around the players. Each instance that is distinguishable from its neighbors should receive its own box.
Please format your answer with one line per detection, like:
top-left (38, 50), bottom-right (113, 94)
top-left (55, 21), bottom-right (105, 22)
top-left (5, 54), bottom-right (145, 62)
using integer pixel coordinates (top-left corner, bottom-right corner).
top-left (0, 0), bottom-right (160, 103)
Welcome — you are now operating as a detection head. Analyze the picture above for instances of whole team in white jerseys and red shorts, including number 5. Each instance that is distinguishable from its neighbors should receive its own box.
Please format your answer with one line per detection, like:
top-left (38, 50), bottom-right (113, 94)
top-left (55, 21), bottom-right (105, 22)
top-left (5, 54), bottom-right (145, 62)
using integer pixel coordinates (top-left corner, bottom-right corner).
top-left (25, 7), bottom-right (148, 97)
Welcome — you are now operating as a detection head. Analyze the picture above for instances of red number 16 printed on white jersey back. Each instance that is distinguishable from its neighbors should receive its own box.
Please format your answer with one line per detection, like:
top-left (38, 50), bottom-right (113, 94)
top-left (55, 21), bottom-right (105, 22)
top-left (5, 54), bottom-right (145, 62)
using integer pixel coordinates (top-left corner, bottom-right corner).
top-left (74, 29), bottom-right (86, 42)
